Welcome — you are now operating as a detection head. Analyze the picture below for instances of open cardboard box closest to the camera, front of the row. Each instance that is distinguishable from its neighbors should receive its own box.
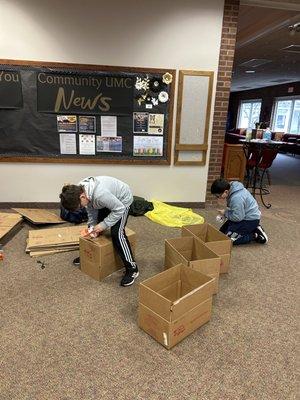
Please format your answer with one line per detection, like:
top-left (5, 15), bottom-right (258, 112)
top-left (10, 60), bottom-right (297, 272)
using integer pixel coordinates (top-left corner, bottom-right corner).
top-left (138, 264), bottom-right (213, 349)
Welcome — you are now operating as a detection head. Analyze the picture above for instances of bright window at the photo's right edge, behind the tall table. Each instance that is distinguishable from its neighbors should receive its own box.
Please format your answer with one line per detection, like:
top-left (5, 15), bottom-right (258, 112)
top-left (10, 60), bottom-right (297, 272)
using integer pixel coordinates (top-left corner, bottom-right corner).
top-left (272, 96), bottom-right (300, 135)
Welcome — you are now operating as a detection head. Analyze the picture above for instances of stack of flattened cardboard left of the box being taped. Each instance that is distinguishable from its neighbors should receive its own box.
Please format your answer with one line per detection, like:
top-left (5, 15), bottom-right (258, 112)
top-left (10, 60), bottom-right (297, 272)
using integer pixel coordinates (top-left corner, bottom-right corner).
top-left (26, 225), bottom-right (82, 257)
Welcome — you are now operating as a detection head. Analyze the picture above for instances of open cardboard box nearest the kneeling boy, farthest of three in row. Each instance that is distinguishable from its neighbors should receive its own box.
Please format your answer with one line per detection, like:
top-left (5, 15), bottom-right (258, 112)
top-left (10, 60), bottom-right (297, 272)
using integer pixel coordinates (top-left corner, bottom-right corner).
top-left (181, 223), bottom-right (232, 274)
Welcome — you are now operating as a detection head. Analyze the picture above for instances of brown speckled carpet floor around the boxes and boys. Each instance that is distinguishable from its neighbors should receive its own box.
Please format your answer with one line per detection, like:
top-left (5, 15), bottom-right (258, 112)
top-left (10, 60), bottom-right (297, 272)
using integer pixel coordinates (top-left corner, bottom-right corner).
top-left (0, 185), bottom-right (300, 400)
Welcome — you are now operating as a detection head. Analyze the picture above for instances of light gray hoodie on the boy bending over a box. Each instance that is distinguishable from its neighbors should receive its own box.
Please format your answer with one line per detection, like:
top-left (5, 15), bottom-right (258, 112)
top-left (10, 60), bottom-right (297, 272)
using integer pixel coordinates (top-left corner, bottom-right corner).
top-left (79, 176), bottom-right (133, 229)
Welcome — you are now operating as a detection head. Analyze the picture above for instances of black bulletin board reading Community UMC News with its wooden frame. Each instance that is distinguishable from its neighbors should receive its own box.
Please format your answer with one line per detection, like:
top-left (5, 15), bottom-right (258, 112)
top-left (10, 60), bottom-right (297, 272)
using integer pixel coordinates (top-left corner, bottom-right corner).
top-left (0, 60), bottom-right (176, 164)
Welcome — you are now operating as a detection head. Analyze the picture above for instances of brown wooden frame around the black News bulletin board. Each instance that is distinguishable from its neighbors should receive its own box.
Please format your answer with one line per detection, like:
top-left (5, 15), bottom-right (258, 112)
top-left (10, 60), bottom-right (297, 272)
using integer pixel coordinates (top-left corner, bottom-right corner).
top-left (0, 59), bottom-right (176, 165)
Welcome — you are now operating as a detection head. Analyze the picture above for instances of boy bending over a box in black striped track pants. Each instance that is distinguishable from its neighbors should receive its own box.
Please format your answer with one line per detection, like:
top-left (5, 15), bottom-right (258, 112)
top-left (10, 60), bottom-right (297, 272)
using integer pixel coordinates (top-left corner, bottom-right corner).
top-left (60, 176), bottom-right (139, 286)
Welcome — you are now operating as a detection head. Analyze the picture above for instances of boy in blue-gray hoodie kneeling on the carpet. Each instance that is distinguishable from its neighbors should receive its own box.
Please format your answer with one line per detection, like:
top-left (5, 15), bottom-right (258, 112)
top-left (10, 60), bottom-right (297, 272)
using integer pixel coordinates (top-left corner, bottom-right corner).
top-left (211, 179), bottom-right (268, 245)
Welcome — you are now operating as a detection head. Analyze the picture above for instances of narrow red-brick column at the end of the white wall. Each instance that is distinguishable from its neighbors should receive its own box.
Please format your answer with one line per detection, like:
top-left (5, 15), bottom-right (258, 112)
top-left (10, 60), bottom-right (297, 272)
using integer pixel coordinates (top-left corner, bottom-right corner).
top-left (206, 0), bottom-right (240, 205)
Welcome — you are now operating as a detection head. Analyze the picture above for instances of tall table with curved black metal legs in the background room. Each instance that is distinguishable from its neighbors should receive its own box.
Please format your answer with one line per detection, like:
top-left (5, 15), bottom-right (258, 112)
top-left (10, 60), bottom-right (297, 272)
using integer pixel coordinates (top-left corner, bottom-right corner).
top-left (240, 139), bottom-right (284, 208)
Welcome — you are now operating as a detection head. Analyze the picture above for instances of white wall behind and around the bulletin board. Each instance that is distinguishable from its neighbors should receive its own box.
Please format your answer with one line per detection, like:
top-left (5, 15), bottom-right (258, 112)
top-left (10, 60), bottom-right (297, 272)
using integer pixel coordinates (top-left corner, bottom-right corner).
top-left (0, 0), bottom-right (224, 202)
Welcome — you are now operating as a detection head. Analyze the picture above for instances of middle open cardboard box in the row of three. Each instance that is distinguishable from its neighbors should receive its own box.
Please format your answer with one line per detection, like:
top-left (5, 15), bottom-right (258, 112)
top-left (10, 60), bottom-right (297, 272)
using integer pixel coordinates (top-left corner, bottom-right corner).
top-left (165, 236), bottom-right (221, 293)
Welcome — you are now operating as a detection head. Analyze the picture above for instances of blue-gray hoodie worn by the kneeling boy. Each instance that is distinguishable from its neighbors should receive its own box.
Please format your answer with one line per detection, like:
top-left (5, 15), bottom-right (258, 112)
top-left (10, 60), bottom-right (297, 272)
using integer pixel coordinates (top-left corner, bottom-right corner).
top-left (225, 181), bottom-right (261, 222)
